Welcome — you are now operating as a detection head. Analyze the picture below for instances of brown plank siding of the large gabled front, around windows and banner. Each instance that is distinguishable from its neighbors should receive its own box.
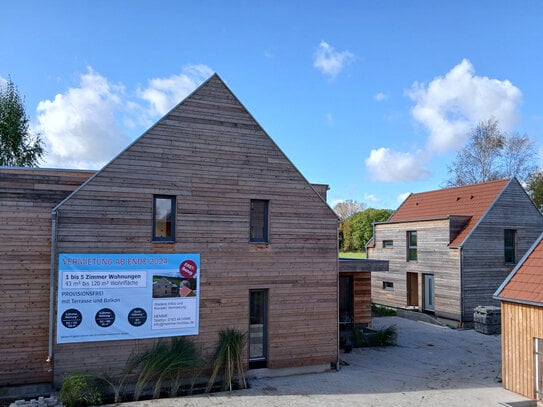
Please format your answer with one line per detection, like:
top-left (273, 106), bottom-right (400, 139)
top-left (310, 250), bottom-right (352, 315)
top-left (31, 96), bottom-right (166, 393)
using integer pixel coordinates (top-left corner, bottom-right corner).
top-left (54, 75), bottom-right (338, 384)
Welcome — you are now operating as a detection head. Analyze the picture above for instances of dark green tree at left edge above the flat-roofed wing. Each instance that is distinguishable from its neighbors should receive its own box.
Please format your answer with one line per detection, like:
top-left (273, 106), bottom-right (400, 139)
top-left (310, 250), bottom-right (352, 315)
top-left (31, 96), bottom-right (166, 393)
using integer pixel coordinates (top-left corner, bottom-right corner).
top-left (0, 79), bottom-right (43, 167)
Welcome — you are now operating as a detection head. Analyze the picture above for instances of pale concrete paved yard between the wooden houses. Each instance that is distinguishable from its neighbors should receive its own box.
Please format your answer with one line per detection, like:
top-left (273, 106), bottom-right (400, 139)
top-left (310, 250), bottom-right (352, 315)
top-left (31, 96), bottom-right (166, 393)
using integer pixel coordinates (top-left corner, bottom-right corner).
top-left (107, 317), bottom-right (535, 407)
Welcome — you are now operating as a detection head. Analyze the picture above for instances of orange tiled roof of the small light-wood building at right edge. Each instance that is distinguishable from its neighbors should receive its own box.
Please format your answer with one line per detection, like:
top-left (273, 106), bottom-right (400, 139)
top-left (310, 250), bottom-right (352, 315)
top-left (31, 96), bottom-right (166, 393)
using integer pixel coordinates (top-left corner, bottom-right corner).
top-left (494, 234), bottom-right (543, 306)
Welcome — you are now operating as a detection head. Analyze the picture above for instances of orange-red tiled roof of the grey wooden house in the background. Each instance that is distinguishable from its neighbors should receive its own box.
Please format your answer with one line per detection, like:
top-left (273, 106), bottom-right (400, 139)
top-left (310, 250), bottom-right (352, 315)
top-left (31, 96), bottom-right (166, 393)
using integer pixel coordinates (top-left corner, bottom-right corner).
top-left (388, 179), bottom-right (510, 246)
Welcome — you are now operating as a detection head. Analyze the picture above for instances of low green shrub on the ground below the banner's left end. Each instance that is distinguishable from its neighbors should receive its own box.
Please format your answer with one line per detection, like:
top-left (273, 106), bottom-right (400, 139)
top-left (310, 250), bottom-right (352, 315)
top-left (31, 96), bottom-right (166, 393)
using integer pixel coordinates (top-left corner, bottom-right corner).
top-left (59, 372), bottom-right (104, 407)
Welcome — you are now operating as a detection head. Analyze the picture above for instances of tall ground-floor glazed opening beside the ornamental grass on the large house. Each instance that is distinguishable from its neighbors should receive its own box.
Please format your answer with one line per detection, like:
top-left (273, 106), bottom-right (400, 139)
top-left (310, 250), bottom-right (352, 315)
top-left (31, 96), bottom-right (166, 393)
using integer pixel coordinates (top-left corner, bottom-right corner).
top-left (249, 289), bottom-right (268, 369)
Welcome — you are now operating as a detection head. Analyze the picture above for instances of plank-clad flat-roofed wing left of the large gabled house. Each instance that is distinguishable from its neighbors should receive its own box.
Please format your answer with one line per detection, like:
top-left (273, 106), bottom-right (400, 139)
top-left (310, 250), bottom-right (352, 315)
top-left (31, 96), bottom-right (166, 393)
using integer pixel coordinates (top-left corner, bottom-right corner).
top-left (0, 168), bottom-right (93, 386)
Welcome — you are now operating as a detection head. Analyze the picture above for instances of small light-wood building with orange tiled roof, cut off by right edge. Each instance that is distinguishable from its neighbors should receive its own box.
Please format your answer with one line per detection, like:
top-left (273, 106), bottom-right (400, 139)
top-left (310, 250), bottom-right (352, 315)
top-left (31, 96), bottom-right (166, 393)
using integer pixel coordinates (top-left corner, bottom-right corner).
top-left (495, 234), bottom-right (543, 401)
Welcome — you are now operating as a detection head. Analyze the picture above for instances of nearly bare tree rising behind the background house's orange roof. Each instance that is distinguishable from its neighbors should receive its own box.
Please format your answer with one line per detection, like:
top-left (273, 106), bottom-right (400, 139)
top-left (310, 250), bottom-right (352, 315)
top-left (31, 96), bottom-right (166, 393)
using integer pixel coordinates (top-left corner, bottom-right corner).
top-left (446, 118), bottom-right (537, 186)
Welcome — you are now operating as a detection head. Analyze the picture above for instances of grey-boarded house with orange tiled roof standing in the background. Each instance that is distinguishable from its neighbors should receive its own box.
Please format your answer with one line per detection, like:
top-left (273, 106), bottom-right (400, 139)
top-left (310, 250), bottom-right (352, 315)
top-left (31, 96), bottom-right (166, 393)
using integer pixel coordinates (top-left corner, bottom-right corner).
top-left (367, 179), bottom-right (543, 325)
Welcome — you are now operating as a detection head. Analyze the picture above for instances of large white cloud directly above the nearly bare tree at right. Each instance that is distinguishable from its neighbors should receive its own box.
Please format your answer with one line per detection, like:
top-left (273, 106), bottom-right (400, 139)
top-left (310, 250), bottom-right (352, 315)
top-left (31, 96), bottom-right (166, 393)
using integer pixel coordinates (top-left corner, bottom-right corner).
top-left (407, 59), bottom-right (522, 153)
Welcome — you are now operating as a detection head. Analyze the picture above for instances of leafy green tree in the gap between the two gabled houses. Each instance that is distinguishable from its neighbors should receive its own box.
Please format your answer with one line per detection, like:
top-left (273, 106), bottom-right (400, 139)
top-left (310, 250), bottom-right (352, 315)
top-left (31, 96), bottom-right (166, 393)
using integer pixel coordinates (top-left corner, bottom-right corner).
top-left (341, 208), bottom-right (394, 252)
